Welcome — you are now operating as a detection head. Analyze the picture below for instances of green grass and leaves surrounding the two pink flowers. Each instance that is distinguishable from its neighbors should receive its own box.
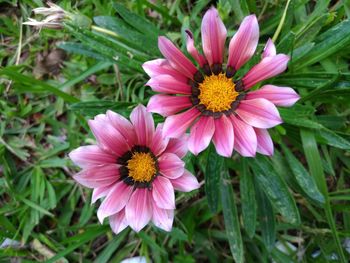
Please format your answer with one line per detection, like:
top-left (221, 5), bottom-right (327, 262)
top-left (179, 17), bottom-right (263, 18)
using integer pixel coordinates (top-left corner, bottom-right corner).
top-left (0, 0), bottom-right (350, 263)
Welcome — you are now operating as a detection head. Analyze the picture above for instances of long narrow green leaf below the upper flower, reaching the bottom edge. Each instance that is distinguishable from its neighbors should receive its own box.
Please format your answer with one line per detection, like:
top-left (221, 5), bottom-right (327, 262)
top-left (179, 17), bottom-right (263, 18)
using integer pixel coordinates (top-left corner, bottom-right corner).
top-left (220, 168), bottom-right (244, 262)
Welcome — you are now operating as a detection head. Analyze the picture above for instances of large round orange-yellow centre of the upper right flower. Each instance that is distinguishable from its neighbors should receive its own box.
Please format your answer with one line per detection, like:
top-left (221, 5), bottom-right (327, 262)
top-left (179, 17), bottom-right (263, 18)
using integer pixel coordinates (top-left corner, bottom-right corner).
top-left (198, 73), bottom-right (239, 112)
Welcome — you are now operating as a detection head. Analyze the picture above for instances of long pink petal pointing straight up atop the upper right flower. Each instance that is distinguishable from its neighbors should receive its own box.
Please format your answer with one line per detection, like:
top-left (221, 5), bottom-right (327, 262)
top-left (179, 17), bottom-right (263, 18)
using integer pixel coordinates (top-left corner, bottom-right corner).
top-left (201, 7), bottom-right (227, 65)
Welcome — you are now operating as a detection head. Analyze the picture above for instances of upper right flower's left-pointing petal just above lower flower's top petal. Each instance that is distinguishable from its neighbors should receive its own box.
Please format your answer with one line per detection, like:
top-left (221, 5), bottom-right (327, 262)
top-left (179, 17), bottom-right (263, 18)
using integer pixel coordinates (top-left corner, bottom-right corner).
top-left (147, 94), bottom-right (192, 117)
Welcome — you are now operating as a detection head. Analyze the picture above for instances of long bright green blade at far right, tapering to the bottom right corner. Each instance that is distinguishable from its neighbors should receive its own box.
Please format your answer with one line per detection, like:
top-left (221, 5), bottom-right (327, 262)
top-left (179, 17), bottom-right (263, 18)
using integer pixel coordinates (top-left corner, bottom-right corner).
top-left (300, 129), bottom-right (347, 263)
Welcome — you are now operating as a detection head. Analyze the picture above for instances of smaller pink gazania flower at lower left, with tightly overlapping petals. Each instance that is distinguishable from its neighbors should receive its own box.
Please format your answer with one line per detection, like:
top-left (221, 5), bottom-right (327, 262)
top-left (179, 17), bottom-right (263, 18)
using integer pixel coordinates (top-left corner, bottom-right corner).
top-left (69, 105), bottom-right (199, 234)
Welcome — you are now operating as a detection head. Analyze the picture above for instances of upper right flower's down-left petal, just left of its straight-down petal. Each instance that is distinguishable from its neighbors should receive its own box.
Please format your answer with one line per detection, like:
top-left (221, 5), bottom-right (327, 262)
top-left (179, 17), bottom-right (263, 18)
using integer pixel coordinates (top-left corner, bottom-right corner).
top-left (188, 116), bottom-right (215, 155)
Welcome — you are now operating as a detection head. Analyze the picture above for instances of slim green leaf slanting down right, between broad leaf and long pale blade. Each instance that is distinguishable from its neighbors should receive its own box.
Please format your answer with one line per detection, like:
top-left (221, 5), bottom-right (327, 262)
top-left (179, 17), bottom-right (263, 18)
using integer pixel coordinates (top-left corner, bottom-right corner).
top-left (281, 144), bottom-right (325, 204)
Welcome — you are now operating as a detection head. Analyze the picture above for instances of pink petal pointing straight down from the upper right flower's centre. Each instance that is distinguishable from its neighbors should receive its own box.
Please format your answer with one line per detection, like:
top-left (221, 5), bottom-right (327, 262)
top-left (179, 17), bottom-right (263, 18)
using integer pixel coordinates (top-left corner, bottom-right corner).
top-left (213, 115), bottom-right (234, 157)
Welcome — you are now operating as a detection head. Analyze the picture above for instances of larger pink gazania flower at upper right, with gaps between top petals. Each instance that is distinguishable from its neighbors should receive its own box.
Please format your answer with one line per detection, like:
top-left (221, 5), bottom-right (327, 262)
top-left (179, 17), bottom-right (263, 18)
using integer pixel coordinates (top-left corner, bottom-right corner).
top-left (143, 7), bottom-right (299, 157)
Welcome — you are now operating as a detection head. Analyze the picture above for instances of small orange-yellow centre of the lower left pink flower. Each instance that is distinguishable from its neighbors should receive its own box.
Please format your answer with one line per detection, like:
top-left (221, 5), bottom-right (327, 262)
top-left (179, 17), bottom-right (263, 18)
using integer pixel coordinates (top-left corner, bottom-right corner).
top-left (127, 152), bottom-right (157, 182)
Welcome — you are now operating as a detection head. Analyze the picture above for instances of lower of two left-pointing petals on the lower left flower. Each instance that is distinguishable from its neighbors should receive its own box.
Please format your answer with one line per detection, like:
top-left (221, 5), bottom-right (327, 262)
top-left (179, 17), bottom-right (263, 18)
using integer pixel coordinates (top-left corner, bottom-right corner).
top-left (73, 164), bottom-right (120, 188)
